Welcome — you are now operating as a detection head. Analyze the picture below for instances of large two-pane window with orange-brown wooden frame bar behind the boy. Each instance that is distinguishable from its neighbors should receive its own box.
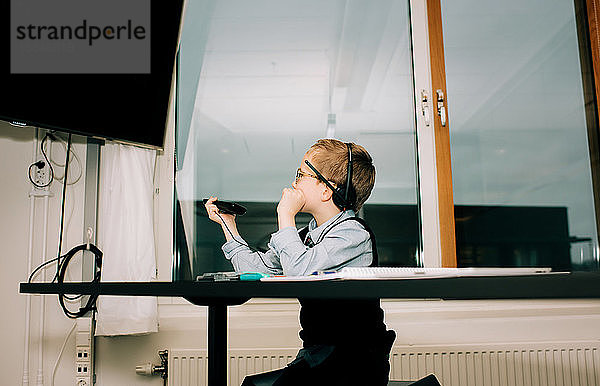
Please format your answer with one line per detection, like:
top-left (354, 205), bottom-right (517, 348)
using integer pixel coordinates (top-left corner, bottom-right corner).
top-left (175, 0), bottom-right (599, 278)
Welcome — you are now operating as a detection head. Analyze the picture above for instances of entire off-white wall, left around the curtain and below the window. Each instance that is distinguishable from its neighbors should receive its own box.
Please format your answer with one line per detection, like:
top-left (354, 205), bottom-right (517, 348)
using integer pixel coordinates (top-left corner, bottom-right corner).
top-left (0, 117), bottom-right (600, 386)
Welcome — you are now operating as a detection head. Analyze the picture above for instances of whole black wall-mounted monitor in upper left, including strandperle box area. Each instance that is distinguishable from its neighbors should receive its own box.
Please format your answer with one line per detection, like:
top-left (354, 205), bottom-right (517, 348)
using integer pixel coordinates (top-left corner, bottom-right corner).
top-left (0, 0), bottom-right (183, 148)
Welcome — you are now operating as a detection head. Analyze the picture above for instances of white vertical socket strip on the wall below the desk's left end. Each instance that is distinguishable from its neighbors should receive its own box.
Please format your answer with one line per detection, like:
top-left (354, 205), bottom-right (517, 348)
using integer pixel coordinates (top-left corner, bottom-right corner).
top-left (75, 317), bottom-right (94, 386)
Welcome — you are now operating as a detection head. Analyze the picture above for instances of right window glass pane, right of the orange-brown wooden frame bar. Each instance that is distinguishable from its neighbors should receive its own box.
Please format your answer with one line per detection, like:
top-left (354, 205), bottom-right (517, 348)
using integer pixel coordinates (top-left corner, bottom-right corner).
top-left (442, 0), bottom-right (598, 270)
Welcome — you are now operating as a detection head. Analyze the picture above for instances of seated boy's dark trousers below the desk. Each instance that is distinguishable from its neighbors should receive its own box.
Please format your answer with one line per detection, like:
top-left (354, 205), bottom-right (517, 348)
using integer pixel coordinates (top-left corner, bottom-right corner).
top-left (242, 334), bottom-right (395, 386)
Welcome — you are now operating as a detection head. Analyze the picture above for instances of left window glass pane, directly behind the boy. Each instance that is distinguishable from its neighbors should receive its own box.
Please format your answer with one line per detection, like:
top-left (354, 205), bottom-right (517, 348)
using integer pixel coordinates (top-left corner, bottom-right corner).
top-left (175, 0), bottom-right (419, 278)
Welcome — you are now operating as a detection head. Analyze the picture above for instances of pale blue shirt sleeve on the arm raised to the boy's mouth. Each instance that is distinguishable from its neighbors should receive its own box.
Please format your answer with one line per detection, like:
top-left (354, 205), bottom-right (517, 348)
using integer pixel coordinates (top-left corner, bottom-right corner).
top-left (269, 221), bottom-right (373, 276)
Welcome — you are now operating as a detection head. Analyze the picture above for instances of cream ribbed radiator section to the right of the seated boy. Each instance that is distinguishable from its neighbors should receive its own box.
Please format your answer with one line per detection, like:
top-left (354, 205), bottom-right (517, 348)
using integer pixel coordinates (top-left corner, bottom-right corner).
top-left (390, 342), bottom-right (600, 386)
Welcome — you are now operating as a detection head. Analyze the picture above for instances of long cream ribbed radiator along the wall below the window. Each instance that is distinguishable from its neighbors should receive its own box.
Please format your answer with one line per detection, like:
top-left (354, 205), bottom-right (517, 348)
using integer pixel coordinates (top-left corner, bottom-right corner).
top-left (168, 342), bottom-right (600, 386)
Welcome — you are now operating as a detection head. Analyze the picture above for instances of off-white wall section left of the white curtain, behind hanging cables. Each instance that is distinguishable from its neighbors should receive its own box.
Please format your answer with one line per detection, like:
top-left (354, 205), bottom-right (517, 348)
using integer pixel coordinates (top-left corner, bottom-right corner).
top-left (0, 122), bottom-right (85, 385)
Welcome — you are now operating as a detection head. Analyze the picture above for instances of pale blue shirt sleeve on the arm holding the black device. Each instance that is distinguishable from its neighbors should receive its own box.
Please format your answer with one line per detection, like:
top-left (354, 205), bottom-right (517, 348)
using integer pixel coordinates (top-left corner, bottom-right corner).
top-left (221, 237), bottom-right (283, 275)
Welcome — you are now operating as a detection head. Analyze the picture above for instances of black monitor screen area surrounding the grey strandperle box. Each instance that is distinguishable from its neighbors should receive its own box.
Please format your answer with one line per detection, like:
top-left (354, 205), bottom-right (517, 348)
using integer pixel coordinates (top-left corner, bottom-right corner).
top-left (0, 0), bottom-right (183, 148)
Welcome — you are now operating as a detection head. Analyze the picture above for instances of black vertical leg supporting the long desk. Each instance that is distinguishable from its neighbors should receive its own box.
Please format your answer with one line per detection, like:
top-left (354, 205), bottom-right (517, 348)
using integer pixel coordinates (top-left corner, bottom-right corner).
top-left (208, 304), bottom-right (227, 386)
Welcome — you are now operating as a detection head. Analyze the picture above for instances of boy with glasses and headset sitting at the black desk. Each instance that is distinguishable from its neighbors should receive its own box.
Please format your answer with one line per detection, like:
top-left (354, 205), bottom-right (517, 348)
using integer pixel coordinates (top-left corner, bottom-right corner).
top-left (206, 139), bottom-right (395, 385)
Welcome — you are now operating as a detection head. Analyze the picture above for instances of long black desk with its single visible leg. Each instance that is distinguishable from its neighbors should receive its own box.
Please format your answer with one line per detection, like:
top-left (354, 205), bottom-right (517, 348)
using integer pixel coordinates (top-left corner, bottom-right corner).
top-left (20, 272), bottom-right (600, 386)
